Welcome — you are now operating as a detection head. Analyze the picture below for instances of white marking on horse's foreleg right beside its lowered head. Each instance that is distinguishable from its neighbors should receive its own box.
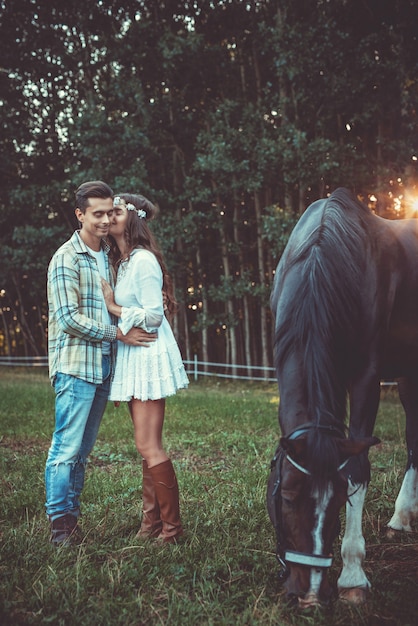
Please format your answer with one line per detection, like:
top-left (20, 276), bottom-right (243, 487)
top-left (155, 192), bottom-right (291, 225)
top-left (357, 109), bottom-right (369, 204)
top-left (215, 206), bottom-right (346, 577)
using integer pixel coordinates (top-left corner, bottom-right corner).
top-left (338, 480), bottom-right (370, 589)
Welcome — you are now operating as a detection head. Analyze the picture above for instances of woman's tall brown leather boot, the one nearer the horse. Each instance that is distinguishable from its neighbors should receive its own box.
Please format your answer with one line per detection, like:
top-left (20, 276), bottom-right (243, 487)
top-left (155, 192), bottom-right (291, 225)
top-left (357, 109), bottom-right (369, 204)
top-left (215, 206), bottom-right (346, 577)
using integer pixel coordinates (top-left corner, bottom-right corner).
top-left (149, 460), bottom-right (183, 543)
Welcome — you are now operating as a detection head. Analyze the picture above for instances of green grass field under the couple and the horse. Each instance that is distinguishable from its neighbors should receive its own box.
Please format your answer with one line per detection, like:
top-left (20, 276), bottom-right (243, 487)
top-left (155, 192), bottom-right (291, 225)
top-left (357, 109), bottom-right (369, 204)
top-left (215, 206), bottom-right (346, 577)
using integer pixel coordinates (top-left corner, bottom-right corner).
top-left (0, 368), bottom-right (418, 626)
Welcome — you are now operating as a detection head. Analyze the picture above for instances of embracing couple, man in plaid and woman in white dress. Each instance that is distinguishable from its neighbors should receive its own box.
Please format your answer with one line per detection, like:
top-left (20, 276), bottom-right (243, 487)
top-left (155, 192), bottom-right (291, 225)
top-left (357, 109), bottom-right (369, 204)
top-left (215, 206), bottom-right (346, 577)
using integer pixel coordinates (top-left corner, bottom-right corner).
top-left (45, 181), bottom-right (188, 546)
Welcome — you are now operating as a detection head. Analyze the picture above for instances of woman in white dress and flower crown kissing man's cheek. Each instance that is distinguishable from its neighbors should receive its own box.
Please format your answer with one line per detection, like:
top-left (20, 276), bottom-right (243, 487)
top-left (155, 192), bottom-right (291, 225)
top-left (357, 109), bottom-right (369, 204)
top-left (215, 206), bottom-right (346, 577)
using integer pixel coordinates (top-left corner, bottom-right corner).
top-left (103, 194), bottom-right (188, 543)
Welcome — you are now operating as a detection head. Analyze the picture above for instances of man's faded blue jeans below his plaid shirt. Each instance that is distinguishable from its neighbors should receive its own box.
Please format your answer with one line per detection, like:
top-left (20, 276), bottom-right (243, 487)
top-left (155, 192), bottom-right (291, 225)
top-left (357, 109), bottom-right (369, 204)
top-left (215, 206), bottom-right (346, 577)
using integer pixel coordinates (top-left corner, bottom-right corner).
top-left (45, 356), bottom-right (110, 521)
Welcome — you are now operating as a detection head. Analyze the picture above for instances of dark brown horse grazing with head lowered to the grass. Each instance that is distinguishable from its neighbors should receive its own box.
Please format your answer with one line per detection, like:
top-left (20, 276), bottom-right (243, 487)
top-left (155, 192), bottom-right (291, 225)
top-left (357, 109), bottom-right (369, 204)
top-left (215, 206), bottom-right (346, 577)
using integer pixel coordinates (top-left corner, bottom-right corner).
top-left (267, 189), bottom-right (418, 607)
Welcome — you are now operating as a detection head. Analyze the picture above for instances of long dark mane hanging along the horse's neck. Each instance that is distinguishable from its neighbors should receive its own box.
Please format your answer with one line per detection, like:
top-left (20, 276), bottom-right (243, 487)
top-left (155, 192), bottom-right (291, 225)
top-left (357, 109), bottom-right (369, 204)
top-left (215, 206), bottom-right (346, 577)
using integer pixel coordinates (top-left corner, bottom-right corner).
top-left (275, 188), bottom-right (372, 486)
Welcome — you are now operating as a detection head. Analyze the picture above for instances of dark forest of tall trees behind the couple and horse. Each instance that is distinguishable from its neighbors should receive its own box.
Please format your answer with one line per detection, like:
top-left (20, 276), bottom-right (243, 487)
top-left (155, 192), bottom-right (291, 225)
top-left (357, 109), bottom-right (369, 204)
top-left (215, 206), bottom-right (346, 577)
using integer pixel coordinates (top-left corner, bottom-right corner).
top-left (0, 0), bottom-right (418, 366)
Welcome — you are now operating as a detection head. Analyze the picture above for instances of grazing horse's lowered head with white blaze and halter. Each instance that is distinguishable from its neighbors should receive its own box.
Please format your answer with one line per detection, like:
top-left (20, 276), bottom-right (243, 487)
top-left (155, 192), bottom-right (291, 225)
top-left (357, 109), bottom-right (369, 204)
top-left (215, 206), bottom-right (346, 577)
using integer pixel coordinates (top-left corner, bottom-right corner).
top-left (267, 425), bottom-right (378, 608)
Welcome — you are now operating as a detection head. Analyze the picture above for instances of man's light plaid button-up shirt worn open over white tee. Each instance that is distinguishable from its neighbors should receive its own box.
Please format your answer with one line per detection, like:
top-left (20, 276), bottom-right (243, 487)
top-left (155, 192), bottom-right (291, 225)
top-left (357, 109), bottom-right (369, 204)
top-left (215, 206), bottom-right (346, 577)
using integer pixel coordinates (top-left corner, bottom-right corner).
top-left (47, 231), bottom-right (117, 384)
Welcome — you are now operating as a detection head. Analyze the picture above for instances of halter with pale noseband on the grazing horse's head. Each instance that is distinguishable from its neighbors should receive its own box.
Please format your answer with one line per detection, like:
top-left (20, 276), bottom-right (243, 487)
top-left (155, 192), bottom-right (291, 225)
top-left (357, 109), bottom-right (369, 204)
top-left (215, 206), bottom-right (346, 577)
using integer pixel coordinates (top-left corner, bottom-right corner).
top-left (270, 424), bottom-right (348, 582)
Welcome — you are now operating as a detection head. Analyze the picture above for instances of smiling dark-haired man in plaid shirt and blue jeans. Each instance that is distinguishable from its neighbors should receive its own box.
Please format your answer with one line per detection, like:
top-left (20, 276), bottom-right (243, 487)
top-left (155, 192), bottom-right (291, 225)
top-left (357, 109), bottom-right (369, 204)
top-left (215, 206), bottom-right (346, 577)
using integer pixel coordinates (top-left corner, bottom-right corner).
top-left (45, 181), bottom-right (156, 546)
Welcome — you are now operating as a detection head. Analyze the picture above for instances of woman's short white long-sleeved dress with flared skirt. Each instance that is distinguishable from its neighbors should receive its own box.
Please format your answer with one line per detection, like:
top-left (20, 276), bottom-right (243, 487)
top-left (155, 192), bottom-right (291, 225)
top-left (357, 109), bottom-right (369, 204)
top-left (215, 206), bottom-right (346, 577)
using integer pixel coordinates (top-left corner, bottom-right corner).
top-left (109, 248), bottom-right (189, 402)
